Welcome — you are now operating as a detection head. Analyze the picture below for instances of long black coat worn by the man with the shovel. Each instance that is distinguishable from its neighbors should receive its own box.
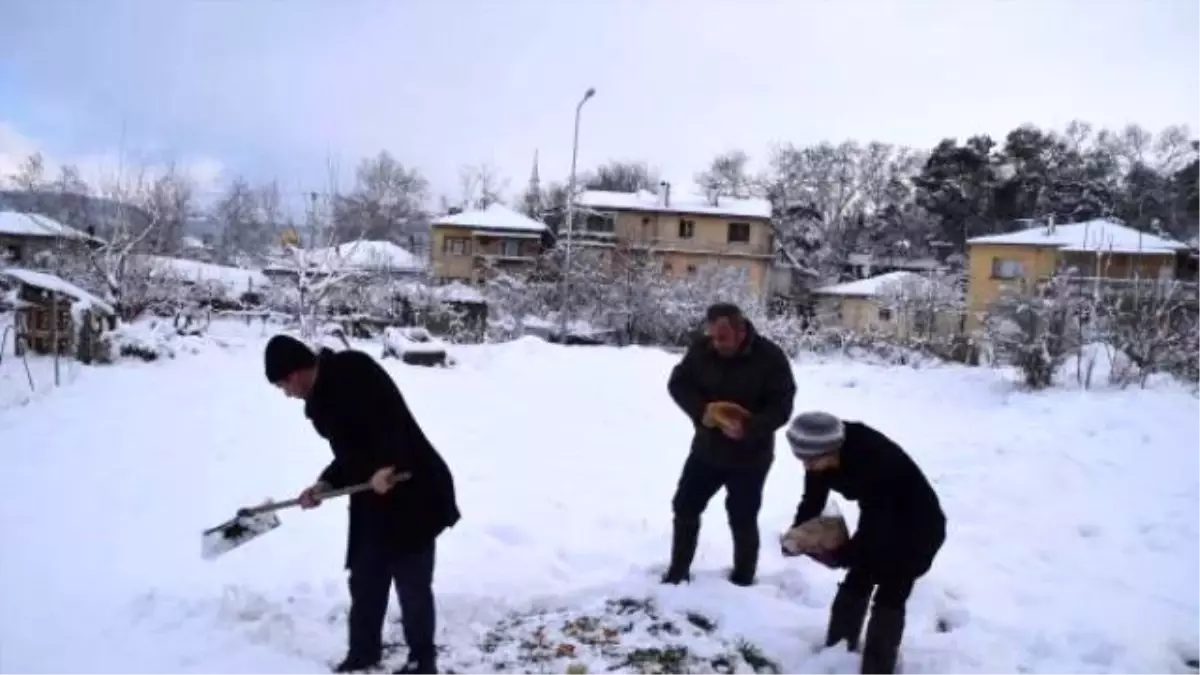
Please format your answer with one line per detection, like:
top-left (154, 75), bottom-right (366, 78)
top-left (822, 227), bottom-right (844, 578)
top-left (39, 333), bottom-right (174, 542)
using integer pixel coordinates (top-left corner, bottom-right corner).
top-left (305, 350), bottom-right (461, 567)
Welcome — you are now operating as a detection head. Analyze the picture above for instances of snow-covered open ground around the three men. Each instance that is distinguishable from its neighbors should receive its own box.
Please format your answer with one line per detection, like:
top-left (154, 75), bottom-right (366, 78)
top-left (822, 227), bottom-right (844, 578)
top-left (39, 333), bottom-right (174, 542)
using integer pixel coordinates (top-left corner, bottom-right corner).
top-left (0, 328), bottom-right (1200, 675)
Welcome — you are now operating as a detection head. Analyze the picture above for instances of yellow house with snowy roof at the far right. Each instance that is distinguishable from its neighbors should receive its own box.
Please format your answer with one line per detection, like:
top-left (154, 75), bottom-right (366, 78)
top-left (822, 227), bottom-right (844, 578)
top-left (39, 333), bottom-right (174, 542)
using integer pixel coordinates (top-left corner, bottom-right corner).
top-left (967, 220), bottom-right (1188, 330)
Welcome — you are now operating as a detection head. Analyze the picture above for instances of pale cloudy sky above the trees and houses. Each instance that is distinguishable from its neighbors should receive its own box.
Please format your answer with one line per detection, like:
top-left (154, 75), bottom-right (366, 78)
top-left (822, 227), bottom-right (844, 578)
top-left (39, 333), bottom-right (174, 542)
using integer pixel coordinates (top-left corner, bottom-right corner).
top-left (0, 0), bottom-right (1200, 205)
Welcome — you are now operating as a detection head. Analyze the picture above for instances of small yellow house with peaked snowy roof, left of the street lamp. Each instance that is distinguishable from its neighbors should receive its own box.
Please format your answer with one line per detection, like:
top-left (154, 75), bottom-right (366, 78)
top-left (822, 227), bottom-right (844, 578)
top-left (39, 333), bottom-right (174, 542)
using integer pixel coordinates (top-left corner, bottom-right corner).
top-left (430, 204), bottom-right (548, 283)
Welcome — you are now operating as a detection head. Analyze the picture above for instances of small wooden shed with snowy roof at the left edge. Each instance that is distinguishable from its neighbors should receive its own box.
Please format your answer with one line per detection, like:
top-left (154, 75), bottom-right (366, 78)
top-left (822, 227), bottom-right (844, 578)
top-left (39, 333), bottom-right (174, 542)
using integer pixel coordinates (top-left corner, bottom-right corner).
top-left (0, 268), bottom-right (116, 363)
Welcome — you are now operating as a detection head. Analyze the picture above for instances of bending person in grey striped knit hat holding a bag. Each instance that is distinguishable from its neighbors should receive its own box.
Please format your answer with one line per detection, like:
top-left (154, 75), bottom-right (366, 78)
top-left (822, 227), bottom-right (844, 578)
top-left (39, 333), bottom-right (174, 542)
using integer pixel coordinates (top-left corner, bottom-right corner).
top-left (782, 412), bottom-right (946, 675)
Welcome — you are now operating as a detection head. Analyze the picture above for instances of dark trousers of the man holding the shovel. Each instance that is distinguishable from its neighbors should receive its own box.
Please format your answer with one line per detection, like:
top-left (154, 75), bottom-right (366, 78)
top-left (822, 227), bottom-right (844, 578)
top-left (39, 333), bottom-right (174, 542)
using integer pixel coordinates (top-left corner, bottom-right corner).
top-left (349, 533), bottom-right (437, 659)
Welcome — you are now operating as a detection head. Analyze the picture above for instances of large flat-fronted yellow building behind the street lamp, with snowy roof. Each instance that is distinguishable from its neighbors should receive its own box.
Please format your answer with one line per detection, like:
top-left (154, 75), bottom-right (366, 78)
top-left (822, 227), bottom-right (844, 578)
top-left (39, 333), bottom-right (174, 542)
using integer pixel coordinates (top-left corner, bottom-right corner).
top-left (575, 184), bottom-right (774, 293)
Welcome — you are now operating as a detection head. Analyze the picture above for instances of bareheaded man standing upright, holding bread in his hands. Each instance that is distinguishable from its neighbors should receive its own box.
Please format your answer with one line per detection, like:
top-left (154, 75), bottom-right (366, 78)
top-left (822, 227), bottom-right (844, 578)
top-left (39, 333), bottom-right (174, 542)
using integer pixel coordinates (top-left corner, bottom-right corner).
top-left (662, 303), bottom-right (796, 586)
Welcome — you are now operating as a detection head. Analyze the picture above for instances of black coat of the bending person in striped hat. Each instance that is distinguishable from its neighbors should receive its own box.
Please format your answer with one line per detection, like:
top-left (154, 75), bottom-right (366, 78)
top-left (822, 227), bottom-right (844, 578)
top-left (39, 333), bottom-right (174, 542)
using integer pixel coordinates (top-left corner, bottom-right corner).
top-left (793, 422), bottom-right (946, 577)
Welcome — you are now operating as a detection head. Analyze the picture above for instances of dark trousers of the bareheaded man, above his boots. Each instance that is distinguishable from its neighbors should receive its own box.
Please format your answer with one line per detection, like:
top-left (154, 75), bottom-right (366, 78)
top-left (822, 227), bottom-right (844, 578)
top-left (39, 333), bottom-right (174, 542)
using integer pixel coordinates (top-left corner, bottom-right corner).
top-left (671, 454), bottom-right (770, 535)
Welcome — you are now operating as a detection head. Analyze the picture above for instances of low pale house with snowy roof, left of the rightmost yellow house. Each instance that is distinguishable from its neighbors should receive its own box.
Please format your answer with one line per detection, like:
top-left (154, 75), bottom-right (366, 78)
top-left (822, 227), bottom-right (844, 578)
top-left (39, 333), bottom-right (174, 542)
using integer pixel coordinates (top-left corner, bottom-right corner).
top-left (812, 271), bottom-right (962, 338)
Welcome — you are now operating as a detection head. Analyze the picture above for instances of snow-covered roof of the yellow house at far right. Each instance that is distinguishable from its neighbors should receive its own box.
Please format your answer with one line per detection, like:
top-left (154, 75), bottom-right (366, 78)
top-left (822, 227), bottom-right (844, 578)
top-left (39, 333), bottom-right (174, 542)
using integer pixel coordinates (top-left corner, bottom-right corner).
top-left (967, 219), bottom-right (1188, 255)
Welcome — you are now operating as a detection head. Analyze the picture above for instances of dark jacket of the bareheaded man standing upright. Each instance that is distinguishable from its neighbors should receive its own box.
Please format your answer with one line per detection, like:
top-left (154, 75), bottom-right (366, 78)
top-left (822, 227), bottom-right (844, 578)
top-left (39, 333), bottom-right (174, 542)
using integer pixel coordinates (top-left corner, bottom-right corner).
top-left (667, 322), bottom-right (796, 467)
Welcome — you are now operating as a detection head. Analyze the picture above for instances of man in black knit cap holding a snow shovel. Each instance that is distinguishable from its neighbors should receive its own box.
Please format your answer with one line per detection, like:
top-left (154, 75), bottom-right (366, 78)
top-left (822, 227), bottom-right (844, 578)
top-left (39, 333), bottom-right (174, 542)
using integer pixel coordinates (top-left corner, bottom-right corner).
top-left (264, 335), bottom-right (460, 675)
